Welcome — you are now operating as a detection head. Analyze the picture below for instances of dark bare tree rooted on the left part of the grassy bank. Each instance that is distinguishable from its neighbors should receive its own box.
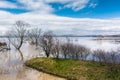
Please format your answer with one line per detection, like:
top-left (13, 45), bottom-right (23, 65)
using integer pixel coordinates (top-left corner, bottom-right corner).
top-left (39, 31), bottom-right (54, 57)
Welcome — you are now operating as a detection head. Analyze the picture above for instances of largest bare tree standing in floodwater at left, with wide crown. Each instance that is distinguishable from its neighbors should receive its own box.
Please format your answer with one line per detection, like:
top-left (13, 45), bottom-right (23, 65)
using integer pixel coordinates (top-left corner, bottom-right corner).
top-left (7, 21), bottom-right (29, 60)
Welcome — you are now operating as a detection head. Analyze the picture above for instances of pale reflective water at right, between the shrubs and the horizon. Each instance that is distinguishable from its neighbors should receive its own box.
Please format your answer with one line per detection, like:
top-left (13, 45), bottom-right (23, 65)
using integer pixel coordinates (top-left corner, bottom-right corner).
top-left (63, 37), bottom-right (120, 51)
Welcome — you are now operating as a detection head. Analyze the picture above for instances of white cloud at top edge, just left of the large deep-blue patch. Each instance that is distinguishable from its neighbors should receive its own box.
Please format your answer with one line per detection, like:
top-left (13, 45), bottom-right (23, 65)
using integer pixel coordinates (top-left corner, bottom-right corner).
top-left (18, 0), bottom-right (54, 13)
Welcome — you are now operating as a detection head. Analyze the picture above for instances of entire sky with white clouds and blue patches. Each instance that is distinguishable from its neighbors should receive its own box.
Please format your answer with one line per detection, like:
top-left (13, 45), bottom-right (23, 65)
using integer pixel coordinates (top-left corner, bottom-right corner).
top-left (0, 0), bottom-right (120, 35)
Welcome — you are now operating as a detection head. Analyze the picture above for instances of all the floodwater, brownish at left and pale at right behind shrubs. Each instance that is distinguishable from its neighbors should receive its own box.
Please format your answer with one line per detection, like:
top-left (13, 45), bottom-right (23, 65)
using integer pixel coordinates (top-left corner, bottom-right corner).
top-left (0, 37), bottom-right (120, 80)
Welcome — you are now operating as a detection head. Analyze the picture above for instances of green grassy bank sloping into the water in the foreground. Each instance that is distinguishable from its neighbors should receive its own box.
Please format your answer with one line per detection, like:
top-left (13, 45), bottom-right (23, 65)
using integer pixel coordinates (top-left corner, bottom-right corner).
top-left (25, 58), bottom-right (120, 80)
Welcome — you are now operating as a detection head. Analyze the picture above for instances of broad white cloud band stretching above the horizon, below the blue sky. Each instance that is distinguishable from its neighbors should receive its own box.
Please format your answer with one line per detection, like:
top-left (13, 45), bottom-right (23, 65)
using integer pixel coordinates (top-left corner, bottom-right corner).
top-left (0, 11), bottom-right (120, 35)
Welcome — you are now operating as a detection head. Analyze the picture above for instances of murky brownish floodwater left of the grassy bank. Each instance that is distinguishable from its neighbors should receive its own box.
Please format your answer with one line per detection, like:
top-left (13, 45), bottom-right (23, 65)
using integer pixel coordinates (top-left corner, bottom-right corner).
top-left (0, 40), bottom-right (64, 80)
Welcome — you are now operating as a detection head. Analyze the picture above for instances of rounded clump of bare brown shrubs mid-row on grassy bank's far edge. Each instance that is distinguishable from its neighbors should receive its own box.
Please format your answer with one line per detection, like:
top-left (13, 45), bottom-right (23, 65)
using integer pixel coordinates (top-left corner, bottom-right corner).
top-left (61, 42), bottom-right (90, 60)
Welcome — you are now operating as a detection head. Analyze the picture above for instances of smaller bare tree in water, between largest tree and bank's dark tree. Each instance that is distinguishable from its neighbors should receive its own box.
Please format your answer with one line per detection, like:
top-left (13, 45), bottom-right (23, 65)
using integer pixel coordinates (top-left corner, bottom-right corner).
top-left (28, 27), bottom-right (41, 47)
